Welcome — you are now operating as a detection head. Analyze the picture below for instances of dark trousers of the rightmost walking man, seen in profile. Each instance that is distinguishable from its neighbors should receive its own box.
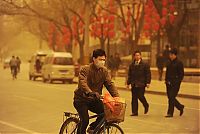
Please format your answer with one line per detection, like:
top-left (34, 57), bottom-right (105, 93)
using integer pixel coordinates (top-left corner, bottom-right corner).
top-left (166, 82), bottom-right (183, 115)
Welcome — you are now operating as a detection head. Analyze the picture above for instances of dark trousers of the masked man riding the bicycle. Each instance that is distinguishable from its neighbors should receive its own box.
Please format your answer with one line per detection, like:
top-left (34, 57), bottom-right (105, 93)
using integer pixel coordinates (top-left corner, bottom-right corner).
top-left (74, 100), bottom-right (104, 134)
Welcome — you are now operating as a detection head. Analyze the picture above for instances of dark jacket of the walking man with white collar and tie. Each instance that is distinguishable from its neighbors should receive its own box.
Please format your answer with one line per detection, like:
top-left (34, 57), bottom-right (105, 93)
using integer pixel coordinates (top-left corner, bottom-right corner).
top-left (127, 60), bottom-right (151, 87)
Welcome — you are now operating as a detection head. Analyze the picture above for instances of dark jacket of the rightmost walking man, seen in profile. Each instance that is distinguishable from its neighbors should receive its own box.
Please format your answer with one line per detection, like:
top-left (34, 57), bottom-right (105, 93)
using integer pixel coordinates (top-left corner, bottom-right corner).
top-left (165, 58), bottom-right (184, 82)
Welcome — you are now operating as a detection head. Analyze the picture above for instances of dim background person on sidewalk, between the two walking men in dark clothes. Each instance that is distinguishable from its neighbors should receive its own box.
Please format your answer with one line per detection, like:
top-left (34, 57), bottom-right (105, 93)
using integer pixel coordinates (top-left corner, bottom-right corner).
top-left (156, 53), bottom-right (165, 81)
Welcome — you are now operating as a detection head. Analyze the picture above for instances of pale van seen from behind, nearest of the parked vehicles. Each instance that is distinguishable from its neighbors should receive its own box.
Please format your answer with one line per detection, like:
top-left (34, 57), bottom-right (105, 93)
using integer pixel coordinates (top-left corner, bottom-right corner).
top-left (42, 52), bottom-right (75, 83)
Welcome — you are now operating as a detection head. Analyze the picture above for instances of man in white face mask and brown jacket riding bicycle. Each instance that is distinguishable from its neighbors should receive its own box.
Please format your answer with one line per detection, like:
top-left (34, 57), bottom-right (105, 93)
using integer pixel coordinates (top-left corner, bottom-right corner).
top-left (74, 49), bottom-right (119, 134)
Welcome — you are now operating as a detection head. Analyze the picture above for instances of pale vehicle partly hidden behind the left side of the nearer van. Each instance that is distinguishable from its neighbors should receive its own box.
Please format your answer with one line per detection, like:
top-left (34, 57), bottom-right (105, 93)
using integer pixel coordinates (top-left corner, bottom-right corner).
top-left (29, 51), bottom-right (49, 80)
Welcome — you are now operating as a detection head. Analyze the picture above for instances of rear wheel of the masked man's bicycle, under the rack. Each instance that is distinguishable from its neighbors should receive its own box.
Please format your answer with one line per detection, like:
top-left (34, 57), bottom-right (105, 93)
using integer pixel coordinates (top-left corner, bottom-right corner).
top-left (59, 117), bottom-right (79, 134)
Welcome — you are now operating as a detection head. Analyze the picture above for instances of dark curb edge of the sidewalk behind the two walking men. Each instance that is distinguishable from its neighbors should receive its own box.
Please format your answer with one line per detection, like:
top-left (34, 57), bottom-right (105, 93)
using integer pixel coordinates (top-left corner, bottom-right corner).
top-left (116, 86), bottom-right (200, 100)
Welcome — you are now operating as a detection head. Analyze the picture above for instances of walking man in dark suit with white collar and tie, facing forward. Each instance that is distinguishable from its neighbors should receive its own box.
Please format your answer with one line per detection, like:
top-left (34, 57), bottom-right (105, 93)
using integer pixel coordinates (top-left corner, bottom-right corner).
top-left (127, 51), bottom-right (151, 116)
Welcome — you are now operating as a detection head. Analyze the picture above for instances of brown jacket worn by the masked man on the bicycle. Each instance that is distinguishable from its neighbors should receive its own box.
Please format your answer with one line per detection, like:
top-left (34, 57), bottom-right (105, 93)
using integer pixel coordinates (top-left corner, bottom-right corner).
top-left (74, 63), bottom-right (119, 101)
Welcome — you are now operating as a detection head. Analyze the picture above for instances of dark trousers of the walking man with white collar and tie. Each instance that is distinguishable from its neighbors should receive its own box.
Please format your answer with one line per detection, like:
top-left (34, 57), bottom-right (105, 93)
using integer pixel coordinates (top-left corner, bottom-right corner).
top-left (131, 87), bottom-right (149, 114)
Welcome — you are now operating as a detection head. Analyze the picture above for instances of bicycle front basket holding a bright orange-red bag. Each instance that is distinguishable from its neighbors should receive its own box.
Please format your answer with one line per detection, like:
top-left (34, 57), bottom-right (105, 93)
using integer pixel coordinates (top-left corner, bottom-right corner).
top-left (104, 101), bottom-right (126, 122)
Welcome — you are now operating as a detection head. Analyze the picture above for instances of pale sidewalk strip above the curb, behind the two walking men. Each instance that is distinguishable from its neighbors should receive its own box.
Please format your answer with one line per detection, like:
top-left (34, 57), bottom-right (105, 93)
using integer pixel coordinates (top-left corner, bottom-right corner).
top-left (113, 77), bottom-right (200, 99)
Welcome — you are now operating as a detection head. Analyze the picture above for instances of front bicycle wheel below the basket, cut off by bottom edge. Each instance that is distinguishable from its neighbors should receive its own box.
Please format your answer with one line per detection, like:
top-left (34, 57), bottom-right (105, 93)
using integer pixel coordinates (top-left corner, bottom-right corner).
top-left (98, 123), bottom-right (124, 134)
